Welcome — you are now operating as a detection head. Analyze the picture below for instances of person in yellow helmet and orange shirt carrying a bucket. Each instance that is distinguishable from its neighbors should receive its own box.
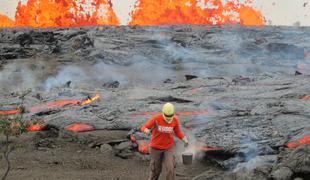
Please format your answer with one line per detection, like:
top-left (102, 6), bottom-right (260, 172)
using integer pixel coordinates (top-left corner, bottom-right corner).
top-left (141, 103), bottom-right (188, 180)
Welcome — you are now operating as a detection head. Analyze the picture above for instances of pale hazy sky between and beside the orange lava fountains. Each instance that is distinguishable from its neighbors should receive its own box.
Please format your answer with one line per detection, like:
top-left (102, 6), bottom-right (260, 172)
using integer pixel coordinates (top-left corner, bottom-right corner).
top-left (0, 0), bottom-right (310, 26)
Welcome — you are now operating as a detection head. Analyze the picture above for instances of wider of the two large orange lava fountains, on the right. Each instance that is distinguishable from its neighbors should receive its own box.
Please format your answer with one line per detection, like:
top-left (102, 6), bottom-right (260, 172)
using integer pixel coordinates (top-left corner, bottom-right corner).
top-left (129, 0), bottom-right (264, 25)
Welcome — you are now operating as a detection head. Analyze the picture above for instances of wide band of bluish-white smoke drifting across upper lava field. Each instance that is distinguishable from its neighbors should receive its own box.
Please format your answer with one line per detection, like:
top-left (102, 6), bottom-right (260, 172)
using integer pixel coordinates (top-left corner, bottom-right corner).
top-left (0, 26), bottom-right (310, 91)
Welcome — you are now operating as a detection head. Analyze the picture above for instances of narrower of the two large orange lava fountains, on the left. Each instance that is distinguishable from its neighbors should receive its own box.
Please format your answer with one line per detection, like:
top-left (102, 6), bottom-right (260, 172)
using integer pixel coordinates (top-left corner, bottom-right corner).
top-left (10, 0), bottom-right (119, 27)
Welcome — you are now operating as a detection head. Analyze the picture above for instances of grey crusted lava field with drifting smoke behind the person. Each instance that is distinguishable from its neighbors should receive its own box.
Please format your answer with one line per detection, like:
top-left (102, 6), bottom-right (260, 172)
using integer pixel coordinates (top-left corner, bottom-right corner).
top-left (0, 26), bottom-right (310, 179)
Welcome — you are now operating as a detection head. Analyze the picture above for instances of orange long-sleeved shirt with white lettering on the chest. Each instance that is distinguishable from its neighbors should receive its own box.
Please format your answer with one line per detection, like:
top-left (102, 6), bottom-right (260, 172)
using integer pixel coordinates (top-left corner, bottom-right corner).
top-left (141, 113), bottom-right (184, 149)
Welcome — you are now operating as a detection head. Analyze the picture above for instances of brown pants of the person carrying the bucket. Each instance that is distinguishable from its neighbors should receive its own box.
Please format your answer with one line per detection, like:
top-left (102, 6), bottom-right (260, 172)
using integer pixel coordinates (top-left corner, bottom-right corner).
top-left (149, 147), bottom-right (176, 180)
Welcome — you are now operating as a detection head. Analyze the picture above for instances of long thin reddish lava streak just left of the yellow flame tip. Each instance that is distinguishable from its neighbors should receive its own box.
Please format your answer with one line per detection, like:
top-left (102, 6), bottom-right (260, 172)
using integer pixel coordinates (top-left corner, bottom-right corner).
top-left (28, 100), bottom-right (81, 113)
